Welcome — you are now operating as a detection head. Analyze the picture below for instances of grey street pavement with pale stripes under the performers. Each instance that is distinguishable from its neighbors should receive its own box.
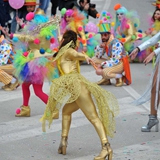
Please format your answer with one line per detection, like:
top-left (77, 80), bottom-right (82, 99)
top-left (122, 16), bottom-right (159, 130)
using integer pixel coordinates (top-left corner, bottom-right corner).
top-left (0, 0), bottom-right (160, 160)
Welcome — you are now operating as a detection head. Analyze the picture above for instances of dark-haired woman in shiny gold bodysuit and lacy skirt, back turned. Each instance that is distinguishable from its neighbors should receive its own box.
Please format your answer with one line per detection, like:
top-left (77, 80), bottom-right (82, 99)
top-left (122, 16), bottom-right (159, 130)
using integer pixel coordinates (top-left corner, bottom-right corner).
top-left (41, 30), bottom-right (119, 160)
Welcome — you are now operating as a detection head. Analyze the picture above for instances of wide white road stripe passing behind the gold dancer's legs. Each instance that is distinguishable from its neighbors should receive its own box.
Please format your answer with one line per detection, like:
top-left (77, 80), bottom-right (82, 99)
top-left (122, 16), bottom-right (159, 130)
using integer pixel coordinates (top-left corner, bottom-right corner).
top-left (0, 97), bottom-right (145, 143)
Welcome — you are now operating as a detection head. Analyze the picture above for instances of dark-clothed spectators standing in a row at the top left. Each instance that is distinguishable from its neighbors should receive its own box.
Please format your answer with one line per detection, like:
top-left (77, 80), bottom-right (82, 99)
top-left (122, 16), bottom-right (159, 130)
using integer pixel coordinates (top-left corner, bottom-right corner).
top-left (0, 0), bottom-right (98, 33)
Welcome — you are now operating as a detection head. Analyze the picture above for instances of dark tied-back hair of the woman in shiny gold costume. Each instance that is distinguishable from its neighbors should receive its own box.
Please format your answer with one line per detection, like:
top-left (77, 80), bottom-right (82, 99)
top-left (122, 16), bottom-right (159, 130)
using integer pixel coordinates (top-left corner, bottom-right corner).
top-left (59, 30), bottom-right (77, 49)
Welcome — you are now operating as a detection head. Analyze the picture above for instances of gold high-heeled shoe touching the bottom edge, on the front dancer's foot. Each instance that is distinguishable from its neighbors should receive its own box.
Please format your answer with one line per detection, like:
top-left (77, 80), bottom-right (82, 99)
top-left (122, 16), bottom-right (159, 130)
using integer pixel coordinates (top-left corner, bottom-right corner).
top-left (94, 142), bottom-right (113, 160)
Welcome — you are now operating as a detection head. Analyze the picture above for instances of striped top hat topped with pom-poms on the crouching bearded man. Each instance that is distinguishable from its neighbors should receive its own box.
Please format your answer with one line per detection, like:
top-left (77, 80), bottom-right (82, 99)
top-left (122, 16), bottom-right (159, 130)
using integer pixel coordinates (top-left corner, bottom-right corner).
top-left (98, 11), bottom-right (112, 33)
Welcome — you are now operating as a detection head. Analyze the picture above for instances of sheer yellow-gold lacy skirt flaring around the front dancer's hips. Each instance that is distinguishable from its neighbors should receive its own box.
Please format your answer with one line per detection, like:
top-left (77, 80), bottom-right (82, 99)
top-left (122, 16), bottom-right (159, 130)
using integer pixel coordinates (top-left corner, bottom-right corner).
top-left (41, 73), bottom-right (119, 137)
